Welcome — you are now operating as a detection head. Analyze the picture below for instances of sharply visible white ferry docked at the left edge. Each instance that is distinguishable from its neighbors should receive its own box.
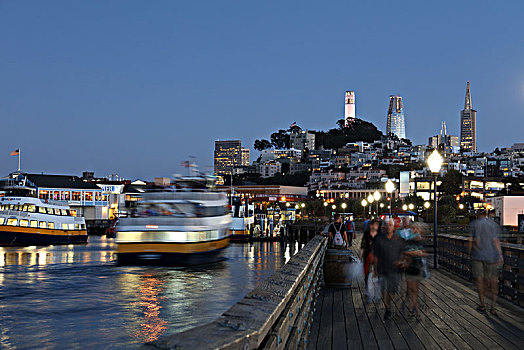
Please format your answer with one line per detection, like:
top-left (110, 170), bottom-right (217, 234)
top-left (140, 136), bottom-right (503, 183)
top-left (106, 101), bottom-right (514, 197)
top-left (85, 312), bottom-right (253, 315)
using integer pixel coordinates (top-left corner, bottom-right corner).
top-left (0, 196), bottom-right (87, 246)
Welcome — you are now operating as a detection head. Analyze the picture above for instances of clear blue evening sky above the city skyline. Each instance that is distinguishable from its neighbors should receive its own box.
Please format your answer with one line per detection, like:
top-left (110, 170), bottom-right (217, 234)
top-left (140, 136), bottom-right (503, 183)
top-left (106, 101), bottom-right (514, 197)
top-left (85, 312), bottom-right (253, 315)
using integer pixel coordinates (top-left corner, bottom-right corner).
top-left (0, 0), bottom-right (524, 179)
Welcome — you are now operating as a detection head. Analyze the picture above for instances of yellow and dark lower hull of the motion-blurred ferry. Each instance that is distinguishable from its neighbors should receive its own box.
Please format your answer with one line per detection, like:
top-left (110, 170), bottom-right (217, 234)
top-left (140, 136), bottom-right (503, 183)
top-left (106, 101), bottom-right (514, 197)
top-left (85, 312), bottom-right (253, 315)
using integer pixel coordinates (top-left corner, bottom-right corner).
top-left (117, 237), bottom-right (229, 266)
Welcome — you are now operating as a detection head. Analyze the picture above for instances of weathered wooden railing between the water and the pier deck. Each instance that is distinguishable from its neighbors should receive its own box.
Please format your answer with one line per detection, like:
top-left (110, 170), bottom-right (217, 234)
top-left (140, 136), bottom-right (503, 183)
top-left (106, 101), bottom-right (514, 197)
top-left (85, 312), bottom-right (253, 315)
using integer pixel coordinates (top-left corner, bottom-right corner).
top-left (143, 236), bottom-right (327, 350)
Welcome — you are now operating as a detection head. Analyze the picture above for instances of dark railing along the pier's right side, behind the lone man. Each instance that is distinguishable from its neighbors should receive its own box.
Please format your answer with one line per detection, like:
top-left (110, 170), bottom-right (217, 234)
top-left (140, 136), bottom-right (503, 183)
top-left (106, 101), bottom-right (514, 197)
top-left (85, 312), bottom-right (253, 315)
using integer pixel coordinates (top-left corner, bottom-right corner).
top-left (438, 234), bottom-right (524, 306)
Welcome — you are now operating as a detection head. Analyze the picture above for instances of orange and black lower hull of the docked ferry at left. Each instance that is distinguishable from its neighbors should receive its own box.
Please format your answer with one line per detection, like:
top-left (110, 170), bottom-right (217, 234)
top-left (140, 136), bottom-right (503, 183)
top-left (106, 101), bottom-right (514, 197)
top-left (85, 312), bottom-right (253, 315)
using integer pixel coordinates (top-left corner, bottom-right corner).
top-left (0, 227), bottom-right (87, 247)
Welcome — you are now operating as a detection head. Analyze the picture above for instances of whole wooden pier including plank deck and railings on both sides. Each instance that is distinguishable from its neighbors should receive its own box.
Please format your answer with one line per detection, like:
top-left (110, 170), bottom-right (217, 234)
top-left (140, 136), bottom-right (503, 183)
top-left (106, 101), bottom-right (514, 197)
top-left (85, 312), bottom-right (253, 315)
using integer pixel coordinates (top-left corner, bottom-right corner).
top-left (142, 231), bottom-right (524, 350)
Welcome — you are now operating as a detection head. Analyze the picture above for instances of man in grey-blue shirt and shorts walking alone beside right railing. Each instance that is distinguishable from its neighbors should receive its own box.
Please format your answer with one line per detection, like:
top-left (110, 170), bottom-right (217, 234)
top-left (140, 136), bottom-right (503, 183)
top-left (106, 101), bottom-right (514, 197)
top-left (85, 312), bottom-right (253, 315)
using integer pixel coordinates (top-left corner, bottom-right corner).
top-left (468, 211), bottom-right (503, 315)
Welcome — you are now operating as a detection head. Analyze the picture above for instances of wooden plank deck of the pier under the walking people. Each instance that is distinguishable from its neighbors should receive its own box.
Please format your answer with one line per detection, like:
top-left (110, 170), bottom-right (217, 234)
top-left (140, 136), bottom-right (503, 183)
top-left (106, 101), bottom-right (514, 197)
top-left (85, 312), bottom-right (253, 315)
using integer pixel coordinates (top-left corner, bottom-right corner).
top-left (308, 247), bottom-right (524, 350)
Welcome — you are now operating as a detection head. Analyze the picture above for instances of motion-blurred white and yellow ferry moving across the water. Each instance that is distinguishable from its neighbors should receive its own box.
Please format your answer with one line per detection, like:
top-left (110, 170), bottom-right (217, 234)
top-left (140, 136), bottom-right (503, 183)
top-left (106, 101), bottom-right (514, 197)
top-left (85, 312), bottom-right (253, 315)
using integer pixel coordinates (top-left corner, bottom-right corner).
top-left (115, 177), bottom-right (231, 266)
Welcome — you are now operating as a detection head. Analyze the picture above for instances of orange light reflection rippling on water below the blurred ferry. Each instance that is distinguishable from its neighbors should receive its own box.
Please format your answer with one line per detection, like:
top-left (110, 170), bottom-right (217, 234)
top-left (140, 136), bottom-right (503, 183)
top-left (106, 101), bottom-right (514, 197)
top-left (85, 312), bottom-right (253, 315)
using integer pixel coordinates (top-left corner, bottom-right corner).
top-left (135, 274), bottom-right (167, 342)
